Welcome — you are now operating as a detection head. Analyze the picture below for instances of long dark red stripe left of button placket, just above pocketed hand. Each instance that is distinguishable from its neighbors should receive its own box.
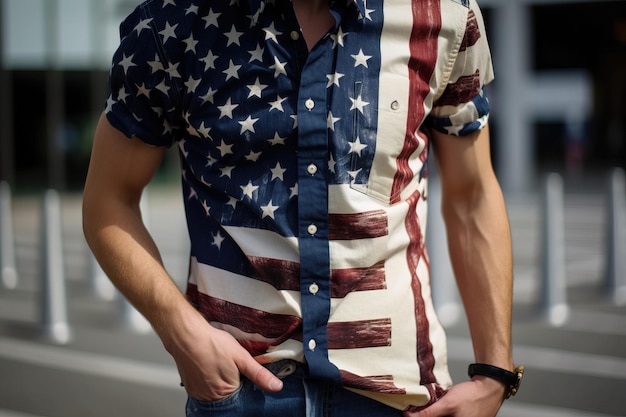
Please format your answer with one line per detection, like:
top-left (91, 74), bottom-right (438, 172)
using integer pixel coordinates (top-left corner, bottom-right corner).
top-left (187, 284), bottom-right (302, 344)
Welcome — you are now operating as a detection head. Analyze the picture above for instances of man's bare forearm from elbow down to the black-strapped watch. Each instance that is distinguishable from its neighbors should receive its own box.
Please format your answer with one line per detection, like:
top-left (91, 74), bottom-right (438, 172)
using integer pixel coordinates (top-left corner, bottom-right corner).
top-left (443, 179), bottom-right (513, 370)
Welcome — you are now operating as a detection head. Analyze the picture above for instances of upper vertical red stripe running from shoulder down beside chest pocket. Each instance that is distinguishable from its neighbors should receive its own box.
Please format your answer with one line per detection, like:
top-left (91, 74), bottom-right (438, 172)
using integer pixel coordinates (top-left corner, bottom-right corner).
top-left (391, 0), bottom-right (441, 203)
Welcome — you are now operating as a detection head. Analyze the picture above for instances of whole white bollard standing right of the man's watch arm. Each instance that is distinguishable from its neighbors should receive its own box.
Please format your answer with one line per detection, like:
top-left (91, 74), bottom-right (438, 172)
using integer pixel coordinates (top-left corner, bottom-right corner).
top-left (540, 173), bottom-right (569, 326)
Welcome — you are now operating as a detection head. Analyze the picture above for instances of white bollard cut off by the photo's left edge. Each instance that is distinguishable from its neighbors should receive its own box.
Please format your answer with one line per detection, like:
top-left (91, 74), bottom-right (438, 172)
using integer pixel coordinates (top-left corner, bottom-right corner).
top-left (0, 181), bottom-right (18, 289)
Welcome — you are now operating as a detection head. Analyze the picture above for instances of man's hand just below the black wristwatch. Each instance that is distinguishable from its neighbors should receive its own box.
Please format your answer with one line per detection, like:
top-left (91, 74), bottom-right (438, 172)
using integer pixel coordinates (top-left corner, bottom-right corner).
top-left (404, 376), bottom-right (505, 417)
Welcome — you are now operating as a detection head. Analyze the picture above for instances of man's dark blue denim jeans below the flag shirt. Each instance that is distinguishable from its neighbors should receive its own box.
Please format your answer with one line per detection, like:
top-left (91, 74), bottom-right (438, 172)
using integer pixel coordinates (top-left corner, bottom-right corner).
top-left (187, 360), bottom-right (402, 417)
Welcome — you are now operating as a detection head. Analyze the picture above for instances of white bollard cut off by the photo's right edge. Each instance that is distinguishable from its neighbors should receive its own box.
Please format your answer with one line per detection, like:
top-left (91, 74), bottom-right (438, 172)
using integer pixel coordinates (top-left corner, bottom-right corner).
top-left (606, 168), bottom-right (626, 306)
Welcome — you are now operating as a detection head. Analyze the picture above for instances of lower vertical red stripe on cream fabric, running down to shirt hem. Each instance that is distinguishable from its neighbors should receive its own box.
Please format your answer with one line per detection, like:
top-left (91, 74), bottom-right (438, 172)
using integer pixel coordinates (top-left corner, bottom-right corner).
top-left (405, 192), bottom-right (436, 385)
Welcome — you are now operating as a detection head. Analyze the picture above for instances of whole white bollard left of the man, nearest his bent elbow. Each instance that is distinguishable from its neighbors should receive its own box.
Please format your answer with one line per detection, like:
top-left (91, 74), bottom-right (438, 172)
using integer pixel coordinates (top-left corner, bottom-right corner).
top-left (40, 190), bottom-right (71, 344)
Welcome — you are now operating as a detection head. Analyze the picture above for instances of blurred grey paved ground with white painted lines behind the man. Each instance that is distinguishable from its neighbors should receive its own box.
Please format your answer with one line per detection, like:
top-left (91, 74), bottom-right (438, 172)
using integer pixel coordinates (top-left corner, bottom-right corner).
top-left (0, 175), bottom-right (626, 417)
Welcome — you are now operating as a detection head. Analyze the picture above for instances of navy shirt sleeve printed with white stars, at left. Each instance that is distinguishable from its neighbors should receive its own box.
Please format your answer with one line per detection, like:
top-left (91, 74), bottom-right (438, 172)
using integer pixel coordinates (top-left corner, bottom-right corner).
top-left (105, 6), bottom-right (178, 146)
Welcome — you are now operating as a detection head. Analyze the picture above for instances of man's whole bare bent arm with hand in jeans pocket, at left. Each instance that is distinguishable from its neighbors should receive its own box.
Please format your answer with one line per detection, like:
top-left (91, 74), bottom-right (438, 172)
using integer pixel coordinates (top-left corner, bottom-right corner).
top-left (83, 116), bottom-right (281, 400)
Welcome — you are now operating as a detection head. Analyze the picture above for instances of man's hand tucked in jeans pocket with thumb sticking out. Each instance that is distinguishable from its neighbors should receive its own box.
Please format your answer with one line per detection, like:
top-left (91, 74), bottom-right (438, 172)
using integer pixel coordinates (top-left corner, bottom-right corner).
top-left (157, 308), bottom-right (282, 401)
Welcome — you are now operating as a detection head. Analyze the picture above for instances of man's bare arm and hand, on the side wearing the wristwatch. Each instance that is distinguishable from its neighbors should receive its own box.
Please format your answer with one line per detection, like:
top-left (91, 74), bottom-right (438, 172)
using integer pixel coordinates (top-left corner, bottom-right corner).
top-left (410, 127), bottom-right (514, 417)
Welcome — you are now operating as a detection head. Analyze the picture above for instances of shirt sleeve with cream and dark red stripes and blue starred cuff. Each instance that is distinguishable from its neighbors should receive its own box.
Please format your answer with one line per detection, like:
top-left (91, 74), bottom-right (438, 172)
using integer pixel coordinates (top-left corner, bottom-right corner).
top-left (427, 0), bottom-right (494, 136)
